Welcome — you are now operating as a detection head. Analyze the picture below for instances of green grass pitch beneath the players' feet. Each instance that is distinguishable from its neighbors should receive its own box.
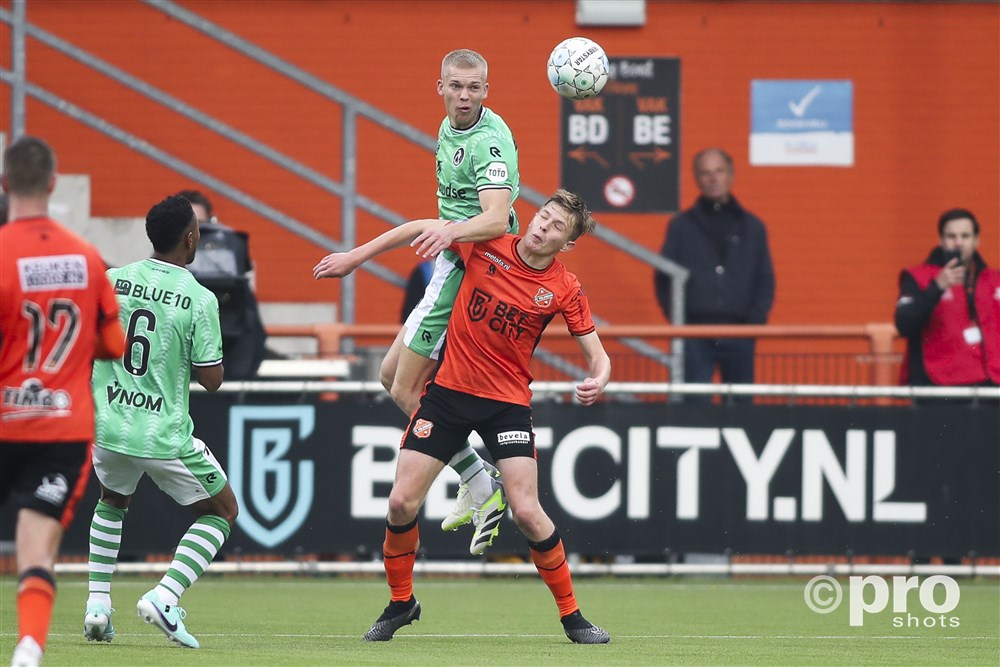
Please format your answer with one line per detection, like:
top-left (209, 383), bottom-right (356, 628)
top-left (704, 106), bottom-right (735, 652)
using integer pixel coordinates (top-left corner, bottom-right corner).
top-left (0, 575), bottom-right (1000, 667)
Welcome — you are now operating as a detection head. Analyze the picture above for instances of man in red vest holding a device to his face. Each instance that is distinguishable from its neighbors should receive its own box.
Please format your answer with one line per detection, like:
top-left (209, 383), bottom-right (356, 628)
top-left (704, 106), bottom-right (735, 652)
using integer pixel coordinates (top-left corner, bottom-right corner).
top-left (895, 208), bottom-right (1000, 386)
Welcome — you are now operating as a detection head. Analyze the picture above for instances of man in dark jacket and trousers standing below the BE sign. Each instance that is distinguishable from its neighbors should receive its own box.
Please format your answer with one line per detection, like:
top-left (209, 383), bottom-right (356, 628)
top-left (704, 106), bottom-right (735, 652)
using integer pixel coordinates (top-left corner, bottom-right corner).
top-left (654, 148), bottom-right (774, 402)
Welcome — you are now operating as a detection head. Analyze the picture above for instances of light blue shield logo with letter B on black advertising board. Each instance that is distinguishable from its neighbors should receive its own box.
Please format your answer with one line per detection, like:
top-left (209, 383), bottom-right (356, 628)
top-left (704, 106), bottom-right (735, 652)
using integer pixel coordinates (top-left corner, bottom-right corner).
top-left (228, 405), bottom-right (316, 547)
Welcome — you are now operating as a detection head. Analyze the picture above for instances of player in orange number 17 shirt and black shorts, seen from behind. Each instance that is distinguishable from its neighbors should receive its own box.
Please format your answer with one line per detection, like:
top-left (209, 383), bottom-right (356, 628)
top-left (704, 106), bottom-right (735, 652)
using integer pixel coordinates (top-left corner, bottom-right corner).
top-left (0, 137), bottom-right (125, 666)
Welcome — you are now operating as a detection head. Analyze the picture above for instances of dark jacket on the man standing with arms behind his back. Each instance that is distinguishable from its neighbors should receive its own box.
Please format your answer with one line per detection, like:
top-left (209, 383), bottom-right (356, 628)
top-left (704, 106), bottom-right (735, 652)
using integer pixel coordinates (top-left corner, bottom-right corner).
top-left (653, 195), bottom-right (774, 324)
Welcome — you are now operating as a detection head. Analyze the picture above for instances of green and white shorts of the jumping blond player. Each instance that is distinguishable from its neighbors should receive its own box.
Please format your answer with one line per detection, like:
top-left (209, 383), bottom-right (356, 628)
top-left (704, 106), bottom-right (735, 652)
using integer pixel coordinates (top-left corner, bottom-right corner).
top-left (403, 251), bottom-right (465, 359)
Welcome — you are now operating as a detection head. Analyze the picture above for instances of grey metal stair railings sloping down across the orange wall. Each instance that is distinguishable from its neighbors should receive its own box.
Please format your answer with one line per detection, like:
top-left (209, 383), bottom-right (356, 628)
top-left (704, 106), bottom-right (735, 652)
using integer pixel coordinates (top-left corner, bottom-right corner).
top-left (0, 0), bottom-right (688, 376)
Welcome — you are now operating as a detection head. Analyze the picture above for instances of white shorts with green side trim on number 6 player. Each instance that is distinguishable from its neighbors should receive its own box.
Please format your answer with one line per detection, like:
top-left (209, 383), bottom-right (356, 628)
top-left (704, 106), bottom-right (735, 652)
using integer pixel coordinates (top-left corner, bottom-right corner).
top-left (93, 438), bottom-right (227, 505)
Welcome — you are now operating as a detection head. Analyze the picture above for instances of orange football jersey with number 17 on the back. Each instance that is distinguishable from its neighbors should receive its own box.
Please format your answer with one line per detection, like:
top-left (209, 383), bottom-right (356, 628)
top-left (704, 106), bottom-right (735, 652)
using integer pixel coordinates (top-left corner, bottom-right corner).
top-left (0, 217), bottom-right (122, 442)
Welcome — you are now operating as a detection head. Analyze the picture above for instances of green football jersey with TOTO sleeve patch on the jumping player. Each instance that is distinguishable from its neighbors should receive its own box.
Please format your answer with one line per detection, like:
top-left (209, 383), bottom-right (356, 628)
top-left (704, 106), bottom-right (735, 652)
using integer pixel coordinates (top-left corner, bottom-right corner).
top-left (436, 107), bottom-right (520, 234)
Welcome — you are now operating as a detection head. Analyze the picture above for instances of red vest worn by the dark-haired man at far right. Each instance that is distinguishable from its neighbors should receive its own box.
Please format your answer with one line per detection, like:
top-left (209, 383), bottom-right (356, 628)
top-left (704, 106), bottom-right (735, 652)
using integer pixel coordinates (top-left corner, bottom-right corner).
top-left (903, 264), bottom-right (1000, 386)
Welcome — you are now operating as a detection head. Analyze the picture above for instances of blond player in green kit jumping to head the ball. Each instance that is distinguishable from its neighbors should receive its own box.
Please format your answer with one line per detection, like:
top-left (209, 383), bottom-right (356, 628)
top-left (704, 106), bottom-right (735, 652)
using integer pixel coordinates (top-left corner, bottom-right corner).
top-left (313, 49), bottom-right (519, 555)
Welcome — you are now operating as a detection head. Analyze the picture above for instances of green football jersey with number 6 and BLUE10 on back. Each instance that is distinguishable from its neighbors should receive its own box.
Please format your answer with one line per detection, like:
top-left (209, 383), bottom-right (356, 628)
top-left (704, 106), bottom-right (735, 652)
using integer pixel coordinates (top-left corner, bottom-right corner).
top-left (92, 259), bottom-right (222, 459)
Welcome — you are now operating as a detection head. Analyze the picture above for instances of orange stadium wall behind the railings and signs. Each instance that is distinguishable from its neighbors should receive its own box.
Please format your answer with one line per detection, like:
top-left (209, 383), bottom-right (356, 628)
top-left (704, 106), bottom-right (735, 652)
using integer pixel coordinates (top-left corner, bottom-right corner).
top-left (0, 0), bottom-right (1000, 342)
